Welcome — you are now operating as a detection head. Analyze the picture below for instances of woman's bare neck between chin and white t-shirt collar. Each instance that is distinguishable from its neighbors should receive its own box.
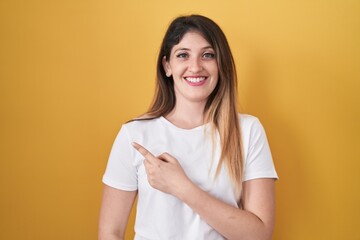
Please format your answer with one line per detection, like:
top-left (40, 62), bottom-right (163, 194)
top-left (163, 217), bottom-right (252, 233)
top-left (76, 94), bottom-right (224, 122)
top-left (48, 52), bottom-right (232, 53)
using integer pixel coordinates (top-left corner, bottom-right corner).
top-left (164, 101), bottom-right (206, 129)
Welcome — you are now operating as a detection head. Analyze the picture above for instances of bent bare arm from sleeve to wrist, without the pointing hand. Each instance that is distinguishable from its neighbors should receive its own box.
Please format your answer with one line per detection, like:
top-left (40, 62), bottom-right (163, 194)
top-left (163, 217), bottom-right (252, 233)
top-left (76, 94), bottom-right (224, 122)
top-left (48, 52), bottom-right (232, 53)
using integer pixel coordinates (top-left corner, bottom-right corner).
top-left (174, 179), bottom-right (275, 240)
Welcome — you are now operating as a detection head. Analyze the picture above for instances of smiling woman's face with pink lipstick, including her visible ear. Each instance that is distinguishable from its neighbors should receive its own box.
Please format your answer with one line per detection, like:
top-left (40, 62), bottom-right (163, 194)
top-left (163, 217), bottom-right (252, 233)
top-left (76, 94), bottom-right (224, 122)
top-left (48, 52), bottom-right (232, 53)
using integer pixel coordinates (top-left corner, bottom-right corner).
top-left (163, 32), bottom-right (218, 104)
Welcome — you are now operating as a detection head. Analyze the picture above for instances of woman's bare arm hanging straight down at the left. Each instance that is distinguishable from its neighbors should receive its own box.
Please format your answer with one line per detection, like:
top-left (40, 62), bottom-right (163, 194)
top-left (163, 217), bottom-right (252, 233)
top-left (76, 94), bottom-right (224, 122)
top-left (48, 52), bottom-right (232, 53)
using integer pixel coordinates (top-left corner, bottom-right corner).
top-left (99, 185), bottom-right (137, 240)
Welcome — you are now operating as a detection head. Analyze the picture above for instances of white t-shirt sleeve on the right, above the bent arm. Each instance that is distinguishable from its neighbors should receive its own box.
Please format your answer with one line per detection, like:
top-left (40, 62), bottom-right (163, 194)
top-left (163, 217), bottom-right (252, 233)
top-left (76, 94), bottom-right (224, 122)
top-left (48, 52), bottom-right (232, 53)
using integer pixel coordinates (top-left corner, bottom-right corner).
top-left (243, 118), bottom-right (278, 181)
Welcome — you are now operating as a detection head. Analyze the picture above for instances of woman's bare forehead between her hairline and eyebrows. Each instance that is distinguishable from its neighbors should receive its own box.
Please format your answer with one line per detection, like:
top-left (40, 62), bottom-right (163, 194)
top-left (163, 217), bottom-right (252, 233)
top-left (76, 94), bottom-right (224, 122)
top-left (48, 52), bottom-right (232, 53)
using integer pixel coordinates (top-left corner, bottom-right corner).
top-left (172, 31), bottom-right (212, 51)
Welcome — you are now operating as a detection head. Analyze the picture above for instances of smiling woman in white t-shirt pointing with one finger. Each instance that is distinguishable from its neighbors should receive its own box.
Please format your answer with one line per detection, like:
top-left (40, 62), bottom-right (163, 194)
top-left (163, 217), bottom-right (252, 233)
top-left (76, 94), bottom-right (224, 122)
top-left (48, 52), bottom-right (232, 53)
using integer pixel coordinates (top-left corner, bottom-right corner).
top-left (99, 15), bottom-right (277, 240)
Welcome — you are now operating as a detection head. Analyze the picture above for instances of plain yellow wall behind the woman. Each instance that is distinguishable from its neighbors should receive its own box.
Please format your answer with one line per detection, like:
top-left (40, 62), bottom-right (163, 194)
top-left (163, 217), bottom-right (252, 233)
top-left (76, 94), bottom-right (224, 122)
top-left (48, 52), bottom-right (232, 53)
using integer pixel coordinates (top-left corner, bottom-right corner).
top-left (0, 0), bottom-right (360, 240)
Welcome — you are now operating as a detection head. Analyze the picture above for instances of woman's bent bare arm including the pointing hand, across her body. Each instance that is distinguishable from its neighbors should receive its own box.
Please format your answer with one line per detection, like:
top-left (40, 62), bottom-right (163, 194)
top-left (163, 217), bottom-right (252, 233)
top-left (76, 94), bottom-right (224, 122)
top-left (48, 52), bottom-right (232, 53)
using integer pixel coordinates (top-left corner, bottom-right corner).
top-left (133, 143), bottom-right (275, 240)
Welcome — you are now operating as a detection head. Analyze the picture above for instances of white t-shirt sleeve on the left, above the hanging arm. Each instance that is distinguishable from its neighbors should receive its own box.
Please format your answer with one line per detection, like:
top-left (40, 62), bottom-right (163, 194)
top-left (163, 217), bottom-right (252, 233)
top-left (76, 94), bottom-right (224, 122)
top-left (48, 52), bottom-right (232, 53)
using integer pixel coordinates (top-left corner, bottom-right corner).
top-left (103, 125), bottom-right (137, 191)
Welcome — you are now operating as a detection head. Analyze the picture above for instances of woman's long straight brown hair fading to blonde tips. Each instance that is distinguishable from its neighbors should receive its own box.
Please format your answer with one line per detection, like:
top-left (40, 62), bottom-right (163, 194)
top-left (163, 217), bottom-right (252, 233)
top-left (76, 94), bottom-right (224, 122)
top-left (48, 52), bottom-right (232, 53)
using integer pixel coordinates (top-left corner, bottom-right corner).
top-left (146, 15), bottom-right (243, 191)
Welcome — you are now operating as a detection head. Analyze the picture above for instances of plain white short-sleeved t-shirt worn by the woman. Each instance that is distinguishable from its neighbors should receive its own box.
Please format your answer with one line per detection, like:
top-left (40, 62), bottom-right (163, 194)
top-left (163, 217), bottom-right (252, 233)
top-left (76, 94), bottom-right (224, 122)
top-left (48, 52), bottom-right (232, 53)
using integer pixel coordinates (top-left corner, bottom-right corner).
top-left (103, 114), bottom-right (277, 240)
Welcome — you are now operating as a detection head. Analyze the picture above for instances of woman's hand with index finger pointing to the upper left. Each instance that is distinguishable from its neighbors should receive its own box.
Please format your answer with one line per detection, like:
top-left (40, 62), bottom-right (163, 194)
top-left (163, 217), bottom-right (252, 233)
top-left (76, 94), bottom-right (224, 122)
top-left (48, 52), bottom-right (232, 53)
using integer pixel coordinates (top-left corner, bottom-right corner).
top-left (133, 142), bottom-right (191, 196)
